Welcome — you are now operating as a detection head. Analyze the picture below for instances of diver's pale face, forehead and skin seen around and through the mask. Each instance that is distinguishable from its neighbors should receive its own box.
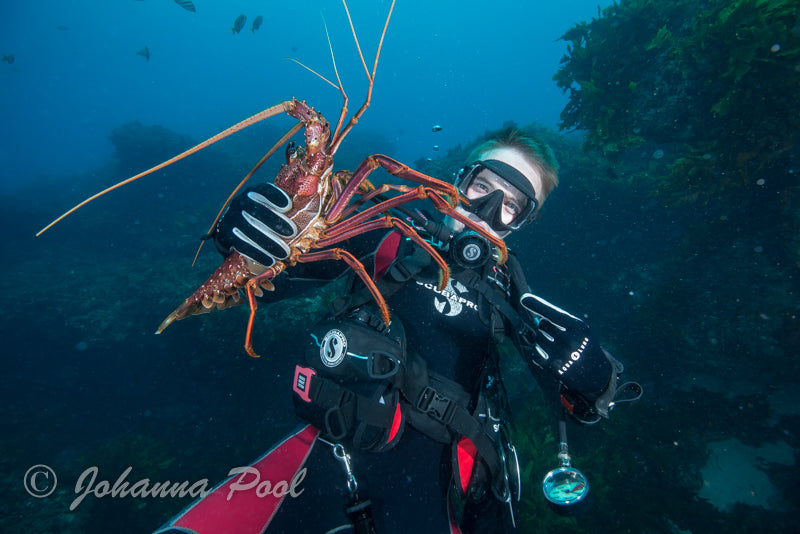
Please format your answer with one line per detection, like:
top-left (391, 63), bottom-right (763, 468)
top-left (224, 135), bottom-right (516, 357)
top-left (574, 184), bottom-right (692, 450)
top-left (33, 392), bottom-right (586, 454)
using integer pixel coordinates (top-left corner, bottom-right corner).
top-left (446, 147), bottom-right (544, 238)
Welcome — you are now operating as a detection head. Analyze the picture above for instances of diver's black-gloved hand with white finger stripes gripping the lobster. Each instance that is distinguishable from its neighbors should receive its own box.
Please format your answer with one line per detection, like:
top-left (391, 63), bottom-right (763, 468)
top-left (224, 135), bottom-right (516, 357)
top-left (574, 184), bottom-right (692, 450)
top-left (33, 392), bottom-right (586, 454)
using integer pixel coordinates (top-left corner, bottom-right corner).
top-left (214, 184), bottom-right (297, 267)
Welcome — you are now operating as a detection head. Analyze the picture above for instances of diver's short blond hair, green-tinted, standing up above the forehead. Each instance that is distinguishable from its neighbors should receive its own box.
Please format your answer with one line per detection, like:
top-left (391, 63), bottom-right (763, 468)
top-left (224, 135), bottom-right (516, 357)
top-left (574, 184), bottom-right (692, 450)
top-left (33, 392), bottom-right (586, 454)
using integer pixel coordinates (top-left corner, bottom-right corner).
top-left (467, 127), bottom-right (558, 198)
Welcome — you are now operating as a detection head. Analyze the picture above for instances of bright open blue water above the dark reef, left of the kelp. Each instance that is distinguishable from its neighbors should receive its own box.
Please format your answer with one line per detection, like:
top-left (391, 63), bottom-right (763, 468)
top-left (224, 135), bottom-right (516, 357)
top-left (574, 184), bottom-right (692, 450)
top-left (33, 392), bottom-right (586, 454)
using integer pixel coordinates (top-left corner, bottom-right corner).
top-left (0, 0), bottom-right (609, 193)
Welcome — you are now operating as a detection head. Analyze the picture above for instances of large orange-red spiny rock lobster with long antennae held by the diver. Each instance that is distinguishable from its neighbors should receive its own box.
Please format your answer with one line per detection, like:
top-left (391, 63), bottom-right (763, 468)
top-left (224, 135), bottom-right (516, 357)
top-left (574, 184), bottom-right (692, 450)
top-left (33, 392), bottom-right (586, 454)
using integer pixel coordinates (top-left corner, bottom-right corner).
top-left (36, 0), bottom-right (506, 357)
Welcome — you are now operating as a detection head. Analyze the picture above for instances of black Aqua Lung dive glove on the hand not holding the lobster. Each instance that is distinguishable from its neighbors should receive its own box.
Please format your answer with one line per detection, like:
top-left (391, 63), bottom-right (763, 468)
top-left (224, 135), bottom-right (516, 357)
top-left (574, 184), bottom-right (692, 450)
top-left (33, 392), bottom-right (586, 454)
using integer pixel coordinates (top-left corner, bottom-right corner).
top-left (520, 293), bottom-right (641, 423)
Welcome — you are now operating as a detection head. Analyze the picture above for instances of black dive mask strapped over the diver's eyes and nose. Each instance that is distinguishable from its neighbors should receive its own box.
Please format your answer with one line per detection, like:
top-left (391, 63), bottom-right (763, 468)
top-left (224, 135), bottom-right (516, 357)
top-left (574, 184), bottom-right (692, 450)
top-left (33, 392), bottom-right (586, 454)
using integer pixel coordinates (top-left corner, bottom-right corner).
top-left (455, 159), bottom-right (538, 232)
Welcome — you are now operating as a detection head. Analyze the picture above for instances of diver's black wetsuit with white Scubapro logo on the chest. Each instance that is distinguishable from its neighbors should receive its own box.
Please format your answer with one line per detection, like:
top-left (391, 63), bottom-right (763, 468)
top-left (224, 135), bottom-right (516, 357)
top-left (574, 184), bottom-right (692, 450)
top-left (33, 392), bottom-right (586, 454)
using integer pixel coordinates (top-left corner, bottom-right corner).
top-left (266, 228), bottom-right (520, 534)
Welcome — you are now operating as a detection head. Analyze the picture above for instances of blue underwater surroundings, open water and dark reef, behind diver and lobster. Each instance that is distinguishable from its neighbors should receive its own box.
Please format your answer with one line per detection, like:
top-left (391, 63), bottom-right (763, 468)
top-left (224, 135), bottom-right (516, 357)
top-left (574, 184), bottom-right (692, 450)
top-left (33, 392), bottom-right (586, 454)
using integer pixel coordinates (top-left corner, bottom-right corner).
top-left (0, 0), bottom-right (800, 534)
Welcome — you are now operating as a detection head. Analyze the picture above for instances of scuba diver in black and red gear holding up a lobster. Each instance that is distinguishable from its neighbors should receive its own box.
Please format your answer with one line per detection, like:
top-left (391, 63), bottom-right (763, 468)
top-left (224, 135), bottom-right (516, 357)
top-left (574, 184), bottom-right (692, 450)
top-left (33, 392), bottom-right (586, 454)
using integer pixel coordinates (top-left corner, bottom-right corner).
top-left (158, 128), bottom-right (641, 534)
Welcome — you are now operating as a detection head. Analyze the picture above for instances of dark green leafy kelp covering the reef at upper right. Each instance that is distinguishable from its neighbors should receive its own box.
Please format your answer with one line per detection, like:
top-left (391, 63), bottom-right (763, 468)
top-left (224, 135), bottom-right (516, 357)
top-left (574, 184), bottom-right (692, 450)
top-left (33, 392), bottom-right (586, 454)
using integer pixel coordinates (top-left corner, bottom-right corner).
top-left (554, 0), bottom-right (800, 294)
